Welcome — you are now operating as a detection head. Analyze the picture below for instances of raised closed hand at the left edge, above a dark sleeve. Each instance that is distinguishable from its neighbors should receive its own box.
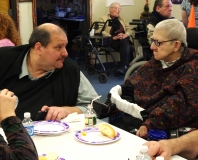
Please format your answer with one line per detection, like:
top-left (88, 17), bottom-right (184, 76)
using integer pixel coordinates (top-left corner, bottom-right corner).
top-left (0, 89), bottom-right (17, 122)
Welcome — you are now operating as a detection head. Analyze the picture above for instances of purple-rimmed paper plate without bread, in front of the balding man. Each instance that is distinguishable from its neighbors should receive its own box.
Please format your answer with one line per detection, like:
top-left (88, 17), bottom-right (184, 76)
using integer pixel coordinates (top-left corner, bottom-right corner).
top-left (34, 121), bottom-right (69, 135)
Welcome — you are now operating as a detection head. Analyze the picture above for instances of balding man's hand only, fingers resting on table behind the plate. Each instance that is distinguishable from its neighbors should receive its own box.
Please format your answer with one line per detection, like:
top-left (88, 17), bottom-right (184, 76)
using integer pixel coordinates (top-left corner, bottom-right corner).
top-left (41, 106), bottom-right (70, 121)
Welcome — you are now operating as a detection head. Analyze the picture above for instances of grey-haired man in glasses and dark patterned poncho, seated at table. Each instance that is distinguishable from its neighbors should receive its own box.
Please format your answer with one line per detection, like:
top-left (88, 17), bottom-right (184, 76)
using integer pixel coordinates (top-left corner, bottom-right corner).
top-left (110, 19), bottom-right (198, 137)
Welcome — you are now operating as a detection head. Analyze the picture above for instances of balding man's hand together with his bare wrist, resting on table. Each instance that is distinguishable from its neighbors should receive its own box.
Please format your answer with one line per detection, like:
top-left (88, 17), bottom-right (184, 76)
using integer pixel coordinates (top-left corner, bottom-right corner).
top-left (41, 106), bottom-right (82, 121)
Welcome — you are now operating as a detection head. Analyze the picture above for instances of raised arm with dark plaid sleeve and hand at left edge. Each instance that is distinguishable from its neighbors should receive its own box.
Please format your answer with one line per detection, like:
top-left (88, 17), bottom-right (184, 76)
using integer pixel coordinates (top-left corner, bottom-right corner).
top-left (0, 89), bottom-right (38, 160)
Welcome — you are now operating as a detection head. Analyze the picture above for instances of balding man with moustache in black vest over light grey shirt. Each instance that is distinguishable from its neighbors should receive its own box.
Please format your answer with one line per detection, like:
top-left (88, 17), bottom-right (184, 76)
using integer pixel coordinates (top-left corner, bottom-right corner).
top-left (0, 23), bottom-right (98, 120)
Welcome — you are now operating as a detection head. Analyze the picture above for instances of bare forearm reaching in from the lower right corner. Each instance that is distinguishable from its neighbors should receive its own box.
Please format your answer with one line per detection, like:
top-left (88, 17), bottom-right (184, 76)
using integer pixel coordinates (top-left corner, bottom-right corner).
top-left (159, 130), bottom-right (198, 159)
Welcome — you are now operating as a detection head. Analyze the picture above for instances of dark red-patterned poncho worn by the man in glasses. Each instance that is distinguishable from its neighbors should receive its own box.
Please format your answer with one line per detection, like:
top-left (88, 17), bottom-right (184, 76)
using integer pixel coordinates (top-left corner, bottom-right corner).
top-left (125, 49), bottom-right (198, 129)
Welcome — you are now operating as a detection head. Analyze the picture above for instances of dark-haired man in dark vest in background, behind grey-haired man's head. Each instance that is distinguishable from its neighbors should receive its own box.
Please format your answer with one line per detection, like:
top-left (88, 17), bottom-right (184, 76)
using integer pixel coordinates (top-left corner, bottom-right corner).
top-left (147, 0), bottom-right (172, 44)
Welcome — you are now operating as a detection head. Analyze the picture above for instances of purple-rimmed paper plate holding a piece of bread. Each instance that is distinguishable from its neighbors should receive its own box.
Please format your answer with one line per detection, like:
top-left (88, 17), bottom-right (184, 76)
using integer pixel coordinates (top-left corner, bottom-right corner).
top-left (75, 128), bottom-right (120, 144)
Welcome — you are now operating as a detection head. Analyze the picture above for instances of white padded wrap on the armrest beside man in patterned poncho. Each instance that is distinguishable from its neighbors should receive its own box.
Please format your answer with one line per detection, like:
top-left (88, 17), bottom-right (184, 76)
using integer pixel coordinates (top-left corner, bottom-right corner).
top-left (110, 85), bottom-right (144, 120)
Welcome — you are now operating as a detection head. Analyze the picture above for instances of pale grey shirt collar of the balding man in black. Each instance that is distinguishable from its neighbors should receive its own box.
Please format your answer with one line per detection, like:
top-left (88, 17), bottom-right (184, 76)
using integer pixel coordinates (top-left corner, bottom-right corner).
top-left (19, 50), bottom-right (54, 81)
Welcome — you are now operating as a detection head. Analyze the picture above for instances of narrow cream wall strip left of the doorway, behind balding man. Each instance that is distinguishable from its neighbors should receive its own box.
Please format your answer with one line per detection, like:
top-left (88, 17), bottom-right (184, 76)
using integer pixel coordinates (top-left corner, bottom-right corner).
top-left (19, 2), bottom-right (33, 44)
